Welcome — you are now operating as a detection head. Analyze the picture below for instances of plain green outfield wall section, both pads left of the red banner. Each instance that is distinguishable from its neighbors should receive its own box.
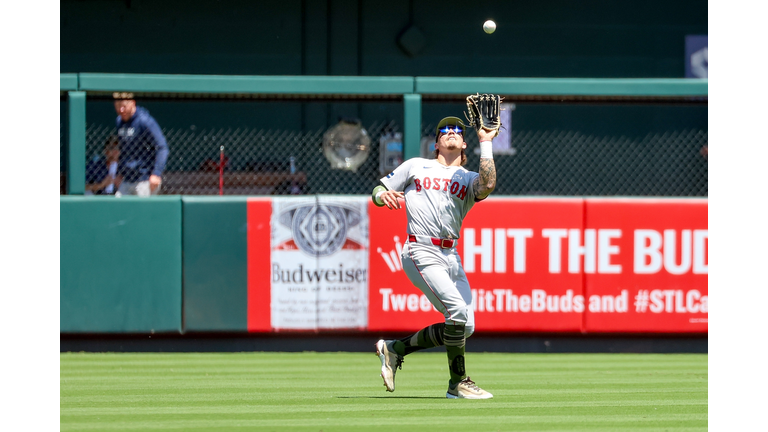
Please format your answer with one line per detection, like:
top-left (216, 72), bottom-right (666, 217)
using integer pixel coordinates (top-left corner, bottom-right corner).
top-left (60, 196), bottom-right (248, 333)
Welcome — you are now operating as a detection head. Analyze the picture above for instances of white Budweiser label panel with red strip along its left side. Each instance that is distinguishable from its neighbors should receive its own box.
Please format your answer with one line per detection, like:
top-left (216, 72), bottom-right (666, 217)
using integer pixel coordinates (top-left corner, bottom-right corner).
top-left (247, 197), bottom-right (369, 331)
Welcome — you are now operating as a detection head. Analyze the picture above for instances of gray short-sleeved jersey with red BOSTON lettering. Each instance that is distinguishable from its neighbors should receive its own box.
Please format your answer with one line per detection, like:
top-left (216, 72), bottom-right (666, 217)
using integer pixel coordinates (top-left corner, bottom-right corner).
top-left (381, 158), bottom-right (480, 239)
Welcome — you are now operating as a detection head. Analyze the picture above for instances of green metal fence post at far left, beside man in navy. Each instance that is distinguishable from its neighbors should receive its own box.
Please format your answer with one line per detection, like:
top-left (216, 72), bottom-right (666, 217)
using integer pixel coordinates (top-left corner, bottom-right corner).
top-left (67, 91), bottom-right (85, 195)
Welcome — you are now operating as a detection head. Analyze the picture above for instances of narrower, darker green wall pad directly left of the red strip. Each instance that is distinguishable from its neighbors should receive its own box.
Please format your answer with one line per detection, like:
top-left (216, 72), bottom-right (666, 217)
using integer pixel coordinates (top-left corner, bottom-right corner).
top-left (182, 197), bottom-right (248, 332)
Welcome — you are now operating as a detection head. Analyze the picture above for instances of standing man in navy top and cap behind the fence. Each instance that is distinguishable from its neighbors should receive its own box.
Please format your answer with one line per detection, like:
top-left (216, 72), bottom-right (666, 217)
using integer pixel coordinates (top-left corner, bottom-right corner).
top-left (113, 92), bottom-right (168, 196)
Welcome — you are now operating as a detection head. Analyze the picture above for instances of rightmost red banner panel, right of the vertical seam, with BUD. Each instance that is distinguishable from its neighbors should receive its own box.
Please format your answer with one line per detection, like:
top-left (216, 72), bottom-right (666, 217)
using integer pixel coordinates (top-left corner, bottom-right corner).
top-left (574, 198), bottom-right (709, 333)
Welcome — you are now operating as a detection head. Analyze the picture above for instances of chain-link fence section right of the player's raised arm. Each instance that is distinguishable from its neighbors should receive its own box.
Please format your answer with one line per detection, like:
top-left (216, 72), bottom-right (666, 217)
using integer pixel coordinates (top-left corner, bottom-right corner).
top-left (480, 130), bottom-right (708, 196)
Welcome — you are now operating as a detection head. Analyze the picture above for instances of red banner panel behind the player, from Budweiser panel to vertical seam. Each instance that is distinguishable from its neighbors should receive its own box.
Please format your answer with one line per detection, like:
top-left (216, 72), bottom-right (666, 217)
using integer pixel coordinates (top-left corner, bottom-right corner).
top-left (368, 198), bottom-right (584, 332)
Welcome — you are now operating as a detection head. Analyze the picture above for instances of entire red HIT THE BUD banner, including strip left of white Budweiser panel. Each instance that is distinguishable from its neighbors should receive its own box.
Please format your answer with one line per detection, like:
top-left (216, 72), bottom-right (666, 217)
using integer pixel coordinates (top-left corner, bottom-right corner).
top-left (248, 198), bottom-right (709, 333)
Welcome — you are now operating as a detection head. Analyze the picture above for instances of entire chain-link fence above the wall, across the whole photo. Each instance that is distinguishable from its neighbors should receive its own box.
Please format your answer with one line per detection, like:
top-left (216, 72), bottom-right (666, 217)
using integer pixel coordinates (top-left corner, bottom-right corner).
top-left (66, 101), bottom-right (708, 197)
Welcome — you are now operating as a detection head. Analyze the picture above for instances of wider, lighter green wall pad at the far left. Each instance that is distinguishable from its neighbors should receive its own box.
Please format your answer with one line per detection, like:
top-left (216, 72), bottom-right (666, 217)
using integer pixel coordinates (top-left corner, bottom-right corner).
top-left (60, 196), bottom-right (182, 333)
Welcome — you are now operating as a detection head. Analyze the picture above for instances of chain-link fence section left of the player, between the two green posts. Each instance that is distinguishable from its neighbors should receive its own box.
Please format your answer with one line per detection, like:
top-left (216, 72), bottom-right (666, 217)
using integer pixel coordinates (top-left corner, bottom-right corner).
top-left (86, 122), bottom-right (400, 195)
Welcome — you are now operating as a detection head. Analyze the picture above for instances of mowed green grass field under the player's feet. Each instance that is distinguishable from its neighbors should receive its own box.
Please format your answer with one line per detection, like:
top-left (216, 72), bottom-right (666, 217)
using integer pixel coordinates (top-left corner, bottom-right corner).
top-left (60, 352), bottom-right (708, 432)
